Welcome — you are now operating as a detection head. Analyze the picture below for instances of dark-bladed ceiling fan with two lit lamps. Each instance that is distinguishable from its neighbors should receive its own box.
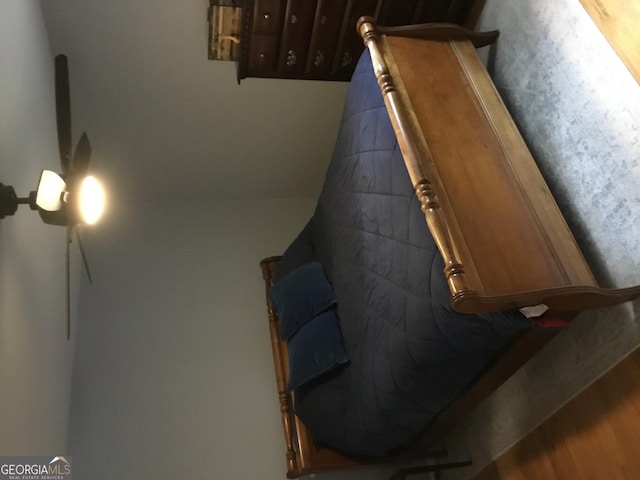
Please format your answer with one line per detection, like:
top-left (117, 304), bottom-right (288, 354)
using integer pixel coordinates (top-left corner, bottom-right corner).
top-left (0, 55), bottom-right (105, 339)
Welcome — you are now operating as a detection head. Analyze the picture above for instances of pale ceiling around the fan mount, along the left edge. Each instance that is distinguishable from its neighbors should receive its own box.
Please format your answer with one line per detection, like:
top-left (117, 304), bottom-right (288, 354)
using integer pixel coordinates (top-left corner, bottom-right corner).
top-left (0, 0), bottom-right (79, 456)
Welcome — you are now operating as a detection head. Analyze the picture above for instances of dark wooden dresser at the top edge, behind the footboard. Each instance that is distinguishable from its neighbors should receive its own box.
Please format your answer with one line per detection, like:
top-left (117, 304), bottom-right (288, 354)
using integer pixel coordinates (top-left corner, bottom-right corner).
top-left (238, 0), bottom-right (484, 82)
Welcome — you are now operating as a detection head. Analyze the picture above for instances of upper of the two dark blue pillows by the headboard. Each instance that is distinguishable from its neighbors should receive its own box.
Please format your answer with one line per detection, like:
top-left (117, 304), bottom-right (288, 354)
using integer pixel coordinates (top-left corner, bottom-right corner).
top-left (269, 262), bottom-right (336, 340)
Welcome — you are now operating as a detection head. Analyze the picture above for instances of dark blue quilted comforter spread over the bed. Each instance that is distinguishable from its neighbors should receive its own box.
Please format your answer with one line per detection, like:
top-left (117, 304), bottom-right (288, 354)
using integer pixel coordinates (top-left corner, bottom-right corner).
top-left (277, 51), bottom-right (531, 457)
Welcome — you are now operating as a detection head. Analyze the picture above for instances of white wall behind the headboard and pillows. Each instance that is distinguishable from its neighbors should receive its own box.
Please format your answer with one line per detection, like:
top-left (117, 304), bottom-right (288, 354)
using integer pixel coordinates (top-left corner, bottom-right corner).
top-left (68, 199), bottom-right (315, 480)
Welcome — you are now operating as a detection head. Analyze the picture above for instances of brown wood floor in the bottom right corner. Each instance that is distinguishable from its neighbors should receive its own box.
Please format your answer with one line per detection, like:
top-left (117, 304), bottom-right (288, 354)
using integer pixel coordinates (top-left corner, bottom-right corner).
top-left (474, 349), bottom-right (640, 480)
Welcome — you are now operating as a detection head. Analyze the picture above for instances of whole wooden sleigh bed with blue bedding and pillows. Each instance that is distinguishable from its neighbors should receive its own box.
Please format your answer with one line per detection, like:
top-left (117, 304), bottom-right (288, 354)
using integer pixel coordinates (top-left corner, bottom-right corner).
top-left (261, 18), bottom-right (640, 478)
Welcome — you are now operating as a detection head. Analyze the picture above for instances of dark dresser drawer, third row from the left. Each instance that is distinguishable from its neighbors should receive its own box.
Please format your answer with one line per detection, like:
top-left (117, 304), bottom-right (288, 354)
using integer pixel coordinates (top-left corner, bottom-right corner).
top-left (306, 0), bottom-right (344, 76)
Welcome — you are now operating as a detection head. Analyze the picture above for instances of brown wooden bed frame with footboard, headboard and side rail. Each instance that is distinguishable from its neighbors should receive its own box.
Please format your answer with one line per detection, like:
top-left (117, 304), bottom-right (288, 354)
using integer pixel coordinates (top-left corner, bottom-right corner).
top-left (261, 17), bottom-right (640, 478)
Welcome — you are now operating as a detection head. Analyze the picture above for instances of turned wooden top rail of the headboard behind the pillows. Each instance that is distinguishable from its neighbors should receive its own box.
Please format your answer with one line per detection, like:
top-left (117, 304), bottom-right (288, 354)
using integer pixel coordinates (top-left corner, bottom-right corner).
top-left (260, 256), bottom-right (300, 478)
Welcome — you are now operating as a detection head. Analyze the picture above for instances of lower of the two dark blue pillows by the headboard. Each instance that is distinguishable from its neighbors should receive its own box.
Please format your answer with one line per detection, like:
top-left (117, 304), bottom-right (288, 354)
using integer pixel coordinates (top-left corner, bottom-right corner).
top-left (288, 310), bottom-right (349, 390)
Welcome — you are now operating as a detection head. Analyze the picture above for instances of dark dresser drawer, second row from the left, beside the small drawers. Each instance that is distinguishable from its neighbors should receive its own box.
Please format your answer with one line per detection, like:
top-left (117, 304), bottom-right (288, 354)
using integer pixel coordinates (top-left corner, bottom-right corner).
top-left (278, 0), bottom-right (316, 77)
